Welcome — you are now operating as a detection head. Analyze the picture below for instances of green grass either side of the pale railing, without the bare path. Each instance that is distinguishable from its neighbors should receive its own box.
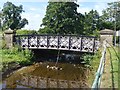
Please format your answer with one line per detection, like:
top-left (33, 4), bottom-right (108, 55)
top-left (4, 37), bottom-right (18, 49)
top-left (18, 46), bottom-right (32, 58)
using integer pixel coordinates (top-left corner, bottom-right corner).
top-left (88, 47), bottom-right (118, 88)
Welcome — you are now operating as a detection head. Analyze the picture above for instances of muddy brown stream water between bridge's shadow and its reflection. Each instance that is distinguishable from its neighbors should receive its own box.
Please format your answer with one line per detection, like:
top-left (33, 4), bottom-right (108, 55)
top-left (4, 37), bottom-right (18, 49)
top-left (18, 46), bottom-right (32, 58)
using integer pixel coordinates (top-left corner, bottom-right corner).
top-left (2, 62), bottom-right (88, 88)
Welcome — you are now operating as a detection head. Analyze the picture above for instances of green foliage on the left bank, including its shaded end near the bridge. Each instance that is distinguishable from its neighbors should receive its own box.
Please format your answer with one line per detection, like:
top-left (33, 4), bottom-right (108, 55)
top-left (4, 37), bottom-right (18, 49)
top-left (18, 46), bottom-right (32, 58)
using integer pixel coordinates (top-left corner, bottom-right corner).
top-left (0, 47), bottom-right (33, 65)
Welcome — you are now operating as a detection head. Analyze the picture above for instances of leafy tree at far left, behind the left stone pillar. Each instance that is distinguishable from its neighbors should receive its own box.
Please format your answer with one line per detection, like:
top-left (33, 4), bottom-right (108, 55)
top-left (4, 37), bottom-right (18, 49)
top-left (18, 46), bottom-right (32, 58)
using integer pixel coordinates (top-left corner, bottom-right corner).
top-left (2, 2), bottom-right (28, 30)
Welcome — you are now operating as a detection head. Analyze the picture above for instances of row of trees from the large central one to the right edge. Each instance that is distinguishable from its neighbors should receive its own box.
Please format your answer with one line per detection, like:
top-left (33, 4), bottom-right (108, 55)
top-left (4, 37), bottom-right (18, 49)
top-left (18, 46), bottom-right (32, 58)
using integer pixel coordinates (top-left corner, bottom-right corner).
top-left (39, 2), bottom-right (120, 36)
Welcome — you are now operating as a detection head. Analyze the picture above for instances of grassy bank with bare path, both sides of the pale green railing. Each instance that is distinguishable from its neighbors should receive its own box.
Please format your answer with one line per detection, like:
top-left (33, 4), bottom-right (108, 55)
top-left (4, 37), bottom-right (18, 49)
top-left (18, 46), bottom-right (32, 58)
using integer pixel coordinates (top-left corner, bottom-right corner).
top-left (88, 47), bottom-right (118, 88)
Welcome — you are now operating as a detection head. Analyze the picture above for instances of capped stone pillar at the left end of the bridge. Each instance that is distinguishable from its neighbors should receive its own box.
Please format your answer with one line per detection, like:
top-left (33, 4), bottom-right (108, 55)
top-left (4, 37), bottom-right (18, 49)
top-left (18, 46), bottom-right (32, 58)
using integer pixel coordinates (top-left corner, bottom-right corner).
top-left (4, 29), bottom-right (15, 48)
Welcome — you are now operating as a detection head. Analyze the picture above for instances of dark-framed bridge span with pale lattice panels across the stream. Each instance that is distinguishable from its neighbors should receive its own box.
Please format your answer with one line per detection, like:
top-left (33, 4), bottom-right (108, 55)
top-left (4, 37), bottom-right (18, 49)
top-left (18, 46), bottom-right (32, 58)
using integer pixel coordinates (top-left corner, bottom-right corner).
top-left (15, 35), bottom-right (99, 53)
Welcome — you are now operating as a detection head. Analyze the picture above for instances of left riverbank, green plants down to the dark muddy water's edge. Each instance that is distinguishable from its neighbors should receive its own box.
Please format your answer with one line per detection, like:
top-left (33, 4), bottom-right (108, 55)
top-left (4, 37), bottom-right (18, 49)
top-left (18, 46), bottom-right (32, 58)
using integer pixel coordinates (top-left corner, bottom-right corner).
top-left (0, 47), bottom-right (32, 78)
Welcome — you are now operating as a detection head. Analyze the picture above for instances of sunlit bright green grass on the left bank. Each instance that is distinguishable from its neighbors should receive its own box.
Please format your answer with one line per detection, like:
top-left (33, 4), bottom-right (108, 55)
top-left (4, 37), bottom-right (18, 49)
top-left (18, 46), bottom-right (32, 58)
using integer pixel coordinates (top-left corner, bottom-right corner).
top-left (0, 48), bottom-right (32, 63)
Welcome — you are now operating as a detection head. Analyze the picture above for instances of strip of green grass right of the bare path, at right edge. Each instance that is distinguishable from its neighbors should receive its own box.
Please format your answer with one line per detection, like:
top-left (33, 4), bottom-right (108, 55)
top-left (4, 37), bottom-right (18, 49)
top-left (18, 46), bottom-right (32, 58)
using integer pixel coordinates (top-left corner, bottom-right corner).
top-left (107, 46), bottom-right (120, 88)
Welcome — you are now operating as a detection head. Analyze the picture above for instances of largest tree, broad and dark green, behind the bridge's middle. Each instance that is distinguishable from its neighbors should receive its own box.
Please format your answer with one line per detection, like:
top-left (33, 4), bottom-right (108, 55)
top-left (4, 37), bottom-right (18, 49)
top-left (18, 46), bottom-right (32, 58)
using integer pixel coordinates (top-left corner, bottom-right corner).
top-left (40, 2), bottom-right (83, 34)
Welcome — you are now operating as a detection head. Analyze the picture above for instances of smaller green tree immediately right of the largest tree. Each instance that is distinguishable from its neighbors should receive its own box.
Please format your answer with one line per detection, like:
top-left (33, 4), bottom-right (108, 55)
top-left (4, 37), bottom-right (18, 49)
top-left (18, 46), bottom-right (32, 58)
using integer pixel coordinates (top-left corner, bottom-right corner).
top-left (84, 10), bottom-right (100, 35)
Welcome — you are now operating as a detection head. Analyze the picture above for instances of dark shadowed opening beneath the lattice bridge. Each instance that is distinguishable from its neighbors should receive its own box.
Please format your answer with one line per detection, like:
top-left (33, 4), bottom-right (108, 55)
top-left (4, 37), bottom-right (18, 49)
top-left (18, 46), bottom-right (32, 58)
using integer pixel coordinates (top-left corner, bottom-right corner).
top-left (32, 49), bottom-right (94, 63)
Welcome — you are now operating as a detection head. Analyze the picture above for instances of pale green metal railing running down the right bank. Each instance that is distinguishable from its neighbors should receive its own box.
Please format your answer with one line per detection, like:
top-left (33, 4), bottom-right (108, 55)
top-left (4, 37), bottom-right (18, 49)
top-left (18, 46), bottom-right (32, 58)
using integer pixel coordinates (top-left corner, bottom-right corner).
top-left (92, 41), bottom-right (106, 90)
